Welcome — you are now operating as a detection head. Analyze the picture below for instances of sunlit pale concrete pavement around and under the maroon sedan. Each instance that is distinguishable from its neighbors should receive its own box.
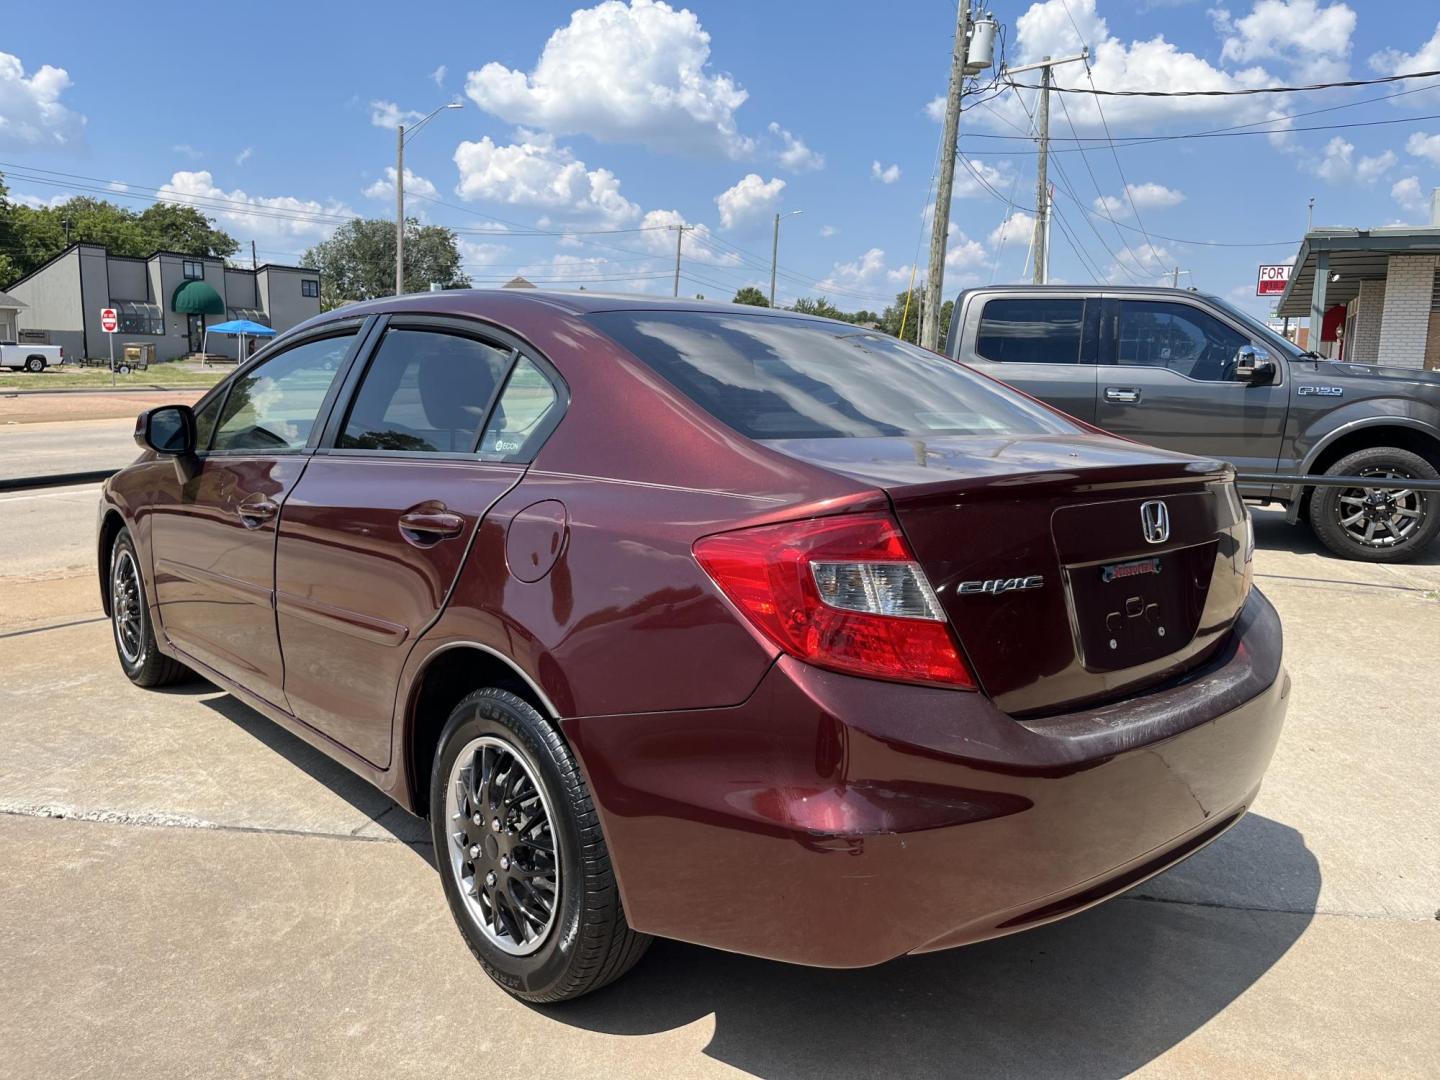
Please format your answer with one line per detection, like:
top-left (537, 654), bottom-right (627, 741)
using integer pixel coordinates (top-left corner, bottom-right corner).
top-left (0, 491), bottom-right (1440, 1080)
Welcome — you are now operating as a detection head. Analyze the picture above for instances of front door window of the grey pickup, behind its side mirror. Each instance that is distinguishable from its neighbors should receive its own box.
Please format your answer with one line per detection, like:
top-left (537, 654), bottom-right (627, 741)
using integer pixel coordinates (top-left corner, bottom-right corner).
top-left (1115, 300), bottom-right (1248, 383)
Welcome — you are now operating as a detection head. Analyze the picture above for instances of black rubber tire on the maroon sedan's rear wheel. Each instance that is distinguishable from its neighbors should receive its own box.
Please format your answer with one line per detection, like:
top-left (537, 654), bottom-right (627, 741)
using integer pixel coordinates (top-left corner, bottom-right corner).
top-left (431, 687), bottom-right (651, 1002)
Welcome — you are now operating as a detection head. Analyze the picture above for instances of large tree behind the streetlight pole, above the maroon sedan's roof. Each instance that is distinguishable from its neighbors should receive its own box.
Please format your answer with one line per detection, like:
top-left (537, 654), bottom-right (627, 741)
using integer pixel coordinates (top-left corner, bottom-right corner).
top-left (304, 217), bottom-right (469, 311)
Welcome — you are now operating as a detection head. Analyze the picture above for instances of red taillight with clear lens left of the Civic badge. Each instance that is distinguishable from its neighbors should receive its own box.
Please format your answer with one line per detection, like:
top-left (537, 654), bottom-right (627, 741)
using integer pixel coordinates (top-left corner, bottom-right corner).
top-left (694, 514), bottom-right (975, 690)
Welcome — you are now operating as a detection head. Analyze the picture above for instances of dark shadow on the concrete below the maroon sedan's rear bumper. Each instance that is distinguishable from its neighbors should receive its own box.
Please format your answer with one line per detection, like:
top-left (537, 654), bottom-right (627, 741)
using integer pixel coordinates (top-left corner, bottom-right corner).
top-left (543, 816), bottom-right (1320, 1080)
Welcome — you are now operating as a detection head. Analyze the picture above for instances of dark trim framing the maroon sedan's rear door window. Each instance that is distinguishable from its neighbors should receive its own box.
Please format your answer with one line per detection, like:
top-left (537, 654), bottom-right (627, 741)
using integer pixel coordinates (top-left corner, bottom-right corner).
top-left (314, 311), bottom-right (570, 465)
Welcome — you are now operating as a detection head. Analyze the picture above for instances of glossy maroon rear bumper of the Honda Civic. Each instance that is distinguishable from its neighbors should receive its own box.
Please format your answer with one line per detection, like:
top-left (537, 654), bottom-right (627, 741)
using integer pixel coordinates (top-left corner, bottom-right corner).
top-left (563, 592), bottom-right (1289, 966)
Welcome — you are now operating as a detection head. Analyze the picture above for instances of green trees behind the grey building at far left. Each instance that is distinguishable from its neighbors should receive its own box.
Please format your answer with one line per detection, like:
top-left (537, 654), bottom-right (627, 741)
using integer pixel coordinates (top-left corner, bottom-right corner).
top-left (0, 174), bottom-right (239, 284)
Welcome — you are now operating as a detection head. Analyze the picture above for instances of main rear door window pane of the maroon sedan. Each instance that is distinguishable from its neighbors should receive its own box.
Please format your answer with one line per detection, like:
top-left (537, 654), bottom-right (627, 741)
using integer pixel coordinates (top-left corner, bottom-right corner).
top-left (336, 328), bottom-right (514, 454)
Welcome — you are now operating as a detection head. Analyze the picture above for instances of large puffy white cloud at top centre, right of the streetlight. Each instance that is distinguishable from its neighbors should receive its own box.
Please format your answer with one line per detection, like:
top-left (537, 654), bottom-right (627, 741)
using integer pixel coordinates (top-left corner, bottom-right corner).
top-left (465, 0), bottom-right (755, 157)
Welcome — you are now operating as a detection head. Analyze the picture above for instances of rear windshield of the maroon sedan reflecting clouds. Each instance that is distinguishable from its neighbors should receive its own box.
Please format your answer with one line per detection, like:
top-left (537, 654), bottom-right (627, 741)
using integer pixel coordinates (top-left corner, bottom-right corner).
top-left (590, 311), bottom-right (1077, 439)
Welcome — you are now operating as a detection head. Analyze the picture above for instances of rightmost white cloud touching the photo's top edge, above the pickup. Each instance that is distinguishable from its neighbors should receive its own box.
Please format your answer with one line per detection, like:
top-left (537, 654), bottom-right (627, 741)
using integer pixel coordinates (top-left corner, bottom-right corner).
top-left (1210, 0), bottom-right (1355, 82)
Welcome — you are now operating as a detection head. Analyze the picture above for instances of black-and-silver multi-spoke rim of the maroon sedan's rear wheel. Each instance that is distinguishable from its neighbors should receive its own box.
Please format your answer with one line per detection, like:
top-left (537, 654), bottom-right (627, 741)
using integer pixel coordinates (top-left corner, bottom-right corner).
top-left (445, 736), bottom-right (560, 956)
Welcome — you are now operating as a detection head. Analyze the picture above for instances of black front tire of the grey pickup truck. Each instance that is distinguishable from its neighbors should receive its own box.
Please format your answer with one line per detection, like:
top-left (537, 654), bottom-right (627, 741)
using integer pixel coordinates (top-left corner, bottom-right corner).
top-left (1310, 446), bottom-right (1440, 563)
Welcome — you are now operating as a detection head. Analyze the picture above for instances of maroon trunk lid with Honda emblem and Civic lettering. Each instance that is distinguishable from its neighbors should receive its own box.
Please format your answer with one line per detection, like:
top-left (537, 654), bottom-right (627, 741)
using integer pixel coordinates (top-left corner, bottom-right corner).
top-left (770, 435), bottom-right (1250, 716)
